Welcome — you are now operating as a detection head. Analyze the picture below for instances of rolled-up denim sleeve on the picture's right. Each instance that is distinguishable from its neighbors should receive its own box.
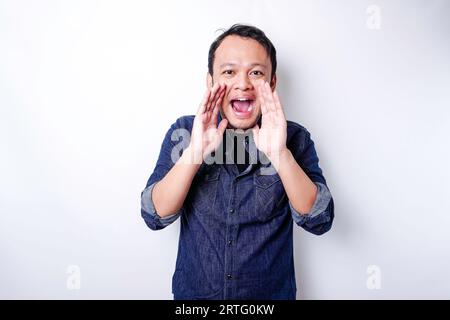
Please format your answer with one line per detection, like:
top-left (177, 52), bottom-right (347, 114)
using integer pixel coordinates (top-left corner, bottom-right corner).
top-left (289, 127), bottom-right (334, 235)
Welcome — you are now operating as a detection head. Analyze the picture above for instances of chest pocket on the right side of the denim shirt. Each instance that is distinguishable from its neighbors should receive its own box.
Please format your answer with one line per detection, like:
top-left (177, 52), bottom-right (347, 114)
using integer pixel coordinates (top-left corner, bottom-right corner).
top-left (253, 172), bottom-right (287, 222)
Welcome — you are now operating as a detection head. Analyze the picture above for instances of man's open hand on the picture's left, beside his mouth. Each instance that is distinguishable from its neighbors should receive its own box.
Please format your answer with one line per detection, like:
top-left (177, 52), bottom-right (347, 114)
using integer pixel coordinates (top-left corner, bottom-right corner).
top-left (188, 83), bottom-right (228, 164)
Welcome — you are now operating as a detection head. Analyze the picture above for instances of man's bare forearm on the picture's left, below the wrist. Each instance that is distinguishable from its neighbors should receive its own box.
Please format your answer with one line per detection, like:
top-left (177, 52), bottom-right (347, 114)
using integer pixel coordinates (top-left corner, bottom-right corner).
top-left (151, 147), bottom-right (200, 218)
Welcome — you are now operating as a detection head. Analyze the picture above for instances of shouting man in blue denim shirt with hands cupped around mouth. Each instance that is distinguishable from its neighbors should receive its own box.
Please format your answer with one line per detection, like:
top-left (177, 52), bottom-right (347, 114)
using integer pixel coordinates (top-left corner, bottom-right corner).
top-left (141, 25), bottom-right (334, 299)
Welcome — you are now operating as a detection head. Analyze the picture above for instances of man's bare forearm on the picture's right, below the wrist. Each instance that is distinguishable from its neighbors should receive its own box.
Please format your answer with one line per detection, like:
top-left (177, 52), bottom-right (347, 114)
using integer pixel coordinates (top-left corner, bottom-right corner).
top-left (275, 148), bottom-right (317, 214)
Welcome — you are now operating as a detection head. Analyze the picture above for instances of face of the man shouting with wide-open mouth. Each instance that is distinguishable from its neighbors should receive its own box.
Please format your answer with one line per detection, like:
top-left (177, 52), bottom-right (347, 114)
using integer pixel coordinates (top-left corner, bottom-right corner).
top-left (207, 35), bottom-right (276, 130)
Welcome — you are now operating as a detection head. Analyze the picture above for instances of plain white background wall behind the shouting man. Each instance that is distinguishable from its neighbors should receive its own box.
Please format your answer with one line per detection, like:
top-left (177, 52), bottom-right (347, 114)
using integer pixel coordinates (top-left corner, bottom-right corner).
top-left (0, 0), bottom-right (450, 299)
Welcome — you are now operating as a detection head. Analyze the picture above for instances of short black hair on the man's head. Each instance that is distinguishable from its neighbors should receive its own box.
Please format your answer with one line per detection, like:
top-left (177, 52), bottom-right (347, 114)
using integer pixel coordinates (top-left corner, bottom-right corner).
top-left (208, 24), bottom-right (277, 80)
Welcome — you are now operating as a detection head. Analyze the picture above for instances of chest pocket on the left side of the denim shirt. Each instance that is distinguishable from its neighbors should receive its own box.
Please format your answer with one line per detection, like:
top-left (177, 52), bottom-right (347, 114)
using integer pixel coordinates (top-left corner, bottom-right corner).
top-left (188, 165), bottom-right (220, 214)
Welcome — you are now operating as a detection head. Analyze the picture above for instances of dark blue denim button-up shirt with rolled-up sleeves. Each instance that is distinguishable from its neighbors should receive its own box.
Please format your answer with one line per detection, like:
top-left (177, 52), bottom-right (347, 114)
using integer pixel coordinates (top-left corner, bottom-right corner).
top-left (141, 116), bottom-right (334, 299)
